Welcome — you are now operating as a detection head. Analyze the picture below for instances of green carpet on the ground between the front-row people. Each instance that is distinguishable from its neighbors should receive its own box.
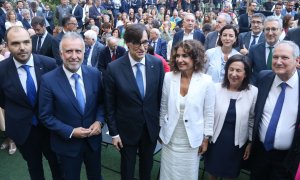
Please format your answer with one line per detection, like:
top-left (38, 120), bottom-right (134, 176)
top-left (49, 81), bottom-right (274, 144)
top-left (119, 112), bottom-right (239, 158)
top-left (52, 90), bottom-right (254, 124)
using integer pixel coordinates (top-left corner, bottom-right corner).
top-left (0, 133), bottom-right (249, 180)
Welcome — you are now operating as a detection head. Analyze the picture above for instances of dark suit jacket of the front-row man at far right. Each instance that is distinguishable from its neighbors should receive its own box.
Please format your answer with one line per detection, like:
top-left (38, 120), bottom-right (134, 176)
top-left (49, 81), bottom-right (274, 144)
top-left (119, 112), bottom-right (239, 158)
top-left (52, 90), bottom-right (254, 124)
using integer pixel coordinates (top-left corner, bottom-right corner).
top-left (252, 70), bottom-right (300, 174)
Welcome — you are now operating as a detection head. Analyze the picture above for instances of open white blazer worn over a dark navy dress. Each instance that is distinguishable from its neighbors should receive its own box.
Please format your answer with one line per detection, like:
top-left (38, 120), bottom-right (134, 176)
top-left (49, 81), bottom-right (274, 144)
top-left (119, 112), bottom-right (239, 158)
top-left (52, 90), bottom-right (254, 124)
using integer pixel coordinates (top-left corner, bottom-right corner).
top-left (212, 83), bottom-right (257, 148)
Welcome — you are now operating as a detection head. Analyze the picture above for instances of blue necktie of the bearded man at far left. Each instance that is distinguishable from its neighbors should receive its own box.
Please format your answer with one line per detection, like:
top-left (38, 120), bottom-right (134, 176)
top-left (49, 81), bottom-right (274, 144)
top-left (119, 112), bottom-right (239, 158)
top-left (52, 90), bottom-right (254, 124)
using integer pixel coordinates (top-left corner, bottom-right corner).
top-left (21, 65), bottom-right (38, 126)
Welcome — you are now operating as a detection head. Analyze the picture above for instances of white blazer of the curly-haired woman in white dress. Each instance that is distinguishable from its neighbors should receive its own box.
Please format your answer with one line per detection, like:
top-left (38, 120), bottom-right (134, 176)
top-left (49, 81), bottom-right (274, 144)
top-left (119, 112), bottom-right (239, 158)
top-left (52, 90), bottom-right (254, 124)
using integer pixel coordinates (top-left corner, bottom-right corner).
top-left (159, 72), bottom-right (215, 148)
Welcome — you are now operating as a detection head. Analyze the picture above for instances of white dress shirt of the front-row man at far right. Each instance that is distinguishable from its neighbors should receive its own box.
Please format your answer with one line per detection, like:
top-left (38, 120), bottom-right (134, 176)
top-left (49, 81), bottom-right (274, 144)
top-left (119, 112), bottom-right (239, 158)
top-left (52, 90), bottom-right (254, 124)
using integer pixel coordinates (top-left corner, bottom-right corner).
top-left (259, 72), bottom-right (299, 150)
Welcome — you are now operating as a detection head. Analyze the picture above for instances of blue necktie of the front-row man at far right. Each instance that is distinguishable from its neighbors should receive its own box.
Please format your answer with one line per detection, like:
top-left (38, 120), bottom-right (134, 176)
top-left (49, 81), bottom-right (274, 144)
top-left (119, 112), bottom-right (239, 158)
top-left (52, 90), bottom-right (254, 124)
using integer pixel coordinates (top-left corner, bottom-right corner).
top-left (264, 82), bottom-right (287, 151)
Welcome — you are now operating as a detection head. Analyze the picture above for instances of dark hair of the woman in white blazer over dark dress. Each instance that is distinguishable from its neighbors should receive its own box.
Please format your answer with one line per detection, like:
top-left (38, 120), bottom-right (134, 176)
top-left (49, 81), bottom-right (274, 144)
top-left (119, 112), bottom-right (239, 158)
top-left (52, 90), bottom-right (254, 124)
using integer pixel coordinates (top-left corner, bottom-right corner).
top-left (222, 54), bottom-right (251, 91)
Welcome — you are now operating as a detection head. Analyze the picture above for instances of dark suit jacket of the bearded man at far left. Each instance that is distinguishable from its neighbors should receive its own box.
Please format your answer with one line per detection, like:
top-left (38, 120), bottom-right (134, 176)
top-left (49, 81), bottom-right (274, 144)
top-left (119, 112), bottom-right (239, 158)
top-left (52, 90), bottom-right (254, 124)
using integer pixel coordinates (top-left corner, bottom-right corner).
top-left (0, 55), bottom-right (56, 145)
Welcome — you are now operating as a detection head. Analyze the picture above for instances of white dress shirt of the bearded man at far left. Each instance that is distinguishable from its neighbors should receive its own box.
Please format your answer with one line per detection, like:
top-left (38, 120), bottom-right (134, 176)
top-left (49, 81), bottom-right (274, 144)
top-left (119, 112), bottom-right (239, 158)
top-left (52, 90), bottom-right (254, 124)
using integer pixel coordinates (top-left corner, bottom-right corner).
top-left (13, 54), bottom-right (37, 94)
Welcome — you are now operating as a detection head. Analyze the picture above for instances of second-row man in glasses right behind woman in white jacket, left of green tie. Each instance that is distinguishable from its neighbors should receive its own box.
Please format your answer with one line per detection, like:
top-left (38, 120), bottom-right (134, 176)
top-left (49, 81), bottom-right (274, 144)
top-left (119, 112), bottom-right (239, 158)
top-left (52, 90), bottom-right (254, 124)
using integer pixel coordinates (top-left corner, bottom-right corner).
top-left (238, 13), bottom-right (265, 55)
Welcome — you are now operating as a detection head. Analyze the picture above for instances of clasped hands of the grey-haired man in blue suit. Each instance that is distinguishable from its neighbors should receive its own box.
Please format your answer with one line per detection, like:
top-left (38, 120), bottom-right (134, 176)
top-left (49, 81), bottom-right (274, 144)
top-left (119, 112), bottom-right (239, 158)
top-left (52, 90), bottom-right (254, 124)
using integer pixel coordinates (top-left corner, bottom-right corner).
top-left (72, 121), bottom-right (101, 138)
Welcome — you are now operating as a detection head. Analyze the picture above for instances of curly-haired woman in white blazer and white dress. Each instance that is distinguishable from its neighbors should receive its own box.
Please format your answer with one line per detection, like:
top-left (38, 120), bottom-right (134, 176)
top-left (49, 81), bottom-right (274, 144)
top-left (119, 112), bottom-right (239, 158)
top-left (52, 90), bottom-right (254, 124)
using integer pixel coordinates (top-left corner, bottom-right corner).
top-left (159, 40), bottom-right (215, 180)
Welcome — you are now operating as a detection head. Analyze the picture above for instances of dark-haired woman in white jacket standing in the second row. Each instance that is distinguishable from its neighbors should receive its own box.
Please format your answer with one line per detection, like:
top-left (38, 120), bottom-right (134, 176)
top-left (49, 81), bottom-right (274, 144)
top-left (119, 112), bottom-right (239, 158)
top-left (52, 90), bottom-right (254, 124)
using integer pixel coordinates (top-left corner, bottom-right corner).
top-left (205, 25), bottom-right (240, 82)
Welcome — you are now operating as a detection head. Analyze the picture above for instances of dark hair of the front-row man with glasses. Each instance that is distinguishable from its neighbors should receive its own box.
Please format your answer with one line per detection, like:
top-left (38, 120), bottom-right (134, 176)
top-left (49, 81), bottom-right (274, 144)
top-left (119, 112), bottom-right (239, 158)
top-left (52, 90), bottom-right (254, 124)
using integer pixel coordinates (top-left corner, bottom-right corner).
top-left (124, 24), bottom-right (147, 43)
